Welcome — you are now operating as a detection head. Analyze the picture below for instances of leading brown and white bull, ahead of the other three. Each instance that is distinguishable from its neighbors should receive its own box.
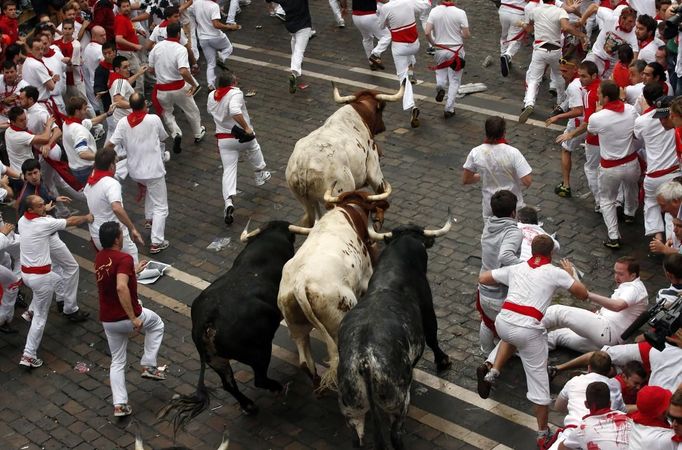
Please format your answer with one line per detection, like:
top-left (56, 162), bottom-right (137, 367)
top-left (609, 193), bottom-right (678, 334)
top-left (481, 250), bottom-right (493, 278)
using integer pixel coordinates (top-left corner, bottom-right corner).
top-left (286, 83), bottom-right (405, 227)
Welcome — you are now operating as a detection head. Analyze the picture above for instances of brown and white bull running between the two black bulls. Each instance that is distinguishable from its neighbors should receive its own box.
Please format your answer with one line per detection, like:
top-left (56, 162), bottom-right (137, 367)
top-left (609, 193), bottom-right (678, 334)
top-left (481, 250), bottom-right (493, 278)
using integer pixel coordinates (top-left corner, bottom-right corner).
top-left (277, 189), bottom-right (388, 388)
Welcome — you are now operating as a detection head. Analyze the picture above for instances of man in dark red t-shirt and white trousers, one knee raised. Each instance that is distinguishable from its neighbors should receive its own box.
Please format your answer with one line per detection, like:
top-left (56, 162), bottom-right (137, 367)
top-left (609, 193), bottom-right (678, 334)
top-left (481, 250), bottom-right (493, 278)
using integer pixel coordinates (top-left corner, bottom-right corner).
top-left (90, 221), bottom-right (166, 417)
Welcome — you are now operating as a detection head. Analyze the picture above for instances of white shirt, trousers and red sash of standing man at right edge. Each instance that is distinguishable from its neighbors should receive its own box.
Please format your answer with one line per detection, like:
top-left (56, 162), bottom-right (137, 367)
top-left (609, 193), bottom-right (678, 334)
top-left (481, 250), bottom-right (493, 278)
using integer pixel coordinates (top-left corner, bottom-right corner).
top-left (634, 108), bottom-right (680, 236)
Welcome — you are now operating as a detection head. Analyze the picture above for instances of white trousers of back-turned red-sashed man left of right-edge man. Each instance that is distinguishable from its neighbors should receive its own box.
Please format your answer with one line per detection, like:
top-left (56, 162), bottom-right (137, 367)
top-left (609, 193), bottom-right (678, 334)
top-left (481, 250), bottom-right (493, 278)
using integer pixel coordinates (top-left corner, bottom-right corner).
top-left (599, 160), bottom-right (639, 239)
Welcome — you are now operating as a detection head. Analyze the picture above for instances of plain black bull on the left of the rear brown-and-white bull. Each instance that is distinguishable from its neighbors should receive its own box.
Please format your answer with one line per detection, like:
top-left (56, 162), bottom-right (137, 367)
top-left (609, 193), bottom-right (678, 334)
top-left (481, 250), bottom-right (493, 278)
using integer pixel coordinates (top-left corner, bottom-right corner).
top-left (159, 221), bottom-right (296, 430)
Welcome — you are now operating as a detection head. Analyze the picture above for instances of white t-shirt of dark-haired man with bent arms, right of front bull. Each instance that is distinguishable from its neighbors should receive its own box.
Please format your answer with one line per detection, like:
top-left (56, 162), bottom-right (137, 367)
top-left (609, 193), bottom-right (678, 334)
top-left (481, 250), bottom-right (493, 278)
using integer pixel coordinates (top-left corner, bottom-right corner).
top-left (463, 144), bottom-right (532, 217)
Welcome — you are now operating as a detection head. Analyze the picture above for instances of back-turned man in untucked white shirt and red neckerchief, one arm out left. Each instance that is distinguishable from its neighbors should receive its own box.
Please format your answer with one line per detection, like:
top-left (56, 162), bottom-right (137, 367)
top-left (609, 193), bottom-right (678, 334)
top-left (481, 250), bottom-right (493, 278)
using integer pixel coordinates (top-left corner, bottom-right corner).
top-left (105, 93), bottom-right (170, 254)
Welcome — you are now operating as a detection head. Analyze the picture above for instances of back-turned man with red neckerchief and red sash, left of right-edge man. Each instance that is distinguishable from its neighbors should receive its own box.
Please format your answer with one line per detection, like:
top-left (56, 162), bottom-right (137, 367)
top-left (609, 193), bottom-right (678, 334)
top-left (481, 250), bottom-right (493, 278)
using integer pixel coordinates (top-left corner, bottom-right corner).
top-left (587, 80), bottom-right (640, 250)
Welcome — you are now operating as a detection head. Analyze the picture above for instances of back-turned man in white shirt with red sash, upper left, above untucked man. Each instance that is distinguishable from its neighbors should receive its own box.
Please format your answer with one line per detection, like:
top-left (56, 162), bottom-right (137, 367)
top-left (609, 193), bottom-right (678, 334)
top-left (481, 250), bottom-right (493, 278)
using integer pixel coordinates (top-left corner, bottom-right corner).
top-left (149, 22), bottom-right (206, 153)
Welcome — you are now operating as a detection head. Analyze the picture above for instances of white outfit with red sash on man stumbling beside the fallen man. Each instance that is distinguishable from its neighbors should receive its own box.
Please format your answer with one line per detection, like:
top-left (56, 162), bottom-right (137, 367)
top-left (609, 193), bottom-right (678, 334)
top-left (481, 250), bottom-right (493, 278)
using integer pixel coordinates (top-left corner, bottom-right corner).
top-left (480, 256), bottom-right (575, 405)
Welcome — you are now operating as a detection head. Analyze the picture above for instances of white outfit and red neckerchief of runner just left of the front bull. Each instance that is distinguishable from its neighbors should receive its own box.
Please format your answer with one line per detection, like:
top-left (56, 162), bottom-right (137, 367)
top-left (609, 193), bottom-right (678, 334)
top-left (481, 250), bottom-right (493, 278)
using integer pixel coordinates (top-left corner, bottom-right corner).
top-left (206, 86), bottom-right (265, 211)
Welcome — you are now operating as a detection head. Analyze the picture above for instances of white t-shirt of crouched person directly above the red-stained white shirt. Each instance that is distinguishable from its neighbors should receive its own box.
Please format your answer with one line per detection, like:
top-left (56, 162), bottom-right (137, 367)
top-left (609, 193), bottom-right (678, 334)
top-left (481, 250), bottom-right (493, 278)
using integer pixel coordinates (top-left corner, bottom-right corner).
top-left (559, 372), bottom-right (625, 426)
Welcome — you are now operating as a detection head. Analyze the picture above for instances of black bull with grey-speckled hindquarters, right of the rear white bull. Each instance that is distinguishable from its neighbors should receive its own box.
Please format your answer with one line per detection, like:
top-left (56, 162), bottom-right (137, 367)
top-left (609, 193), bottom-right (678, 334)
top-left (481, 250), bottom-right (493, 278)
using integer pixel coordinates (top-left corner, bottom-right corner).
top-left (337, 226), bottom-right (451, 449)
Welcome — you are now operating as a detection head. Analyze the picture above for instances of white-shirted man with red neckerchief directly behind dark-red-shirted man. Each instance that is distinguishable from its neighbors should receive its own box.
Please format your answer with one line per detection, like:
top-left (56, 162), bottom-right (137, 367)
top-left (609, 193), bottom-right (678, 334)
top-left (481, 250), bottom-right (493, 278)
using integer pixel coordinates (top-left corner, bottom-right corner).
top-left (83, 148), bottom-right (144, 264)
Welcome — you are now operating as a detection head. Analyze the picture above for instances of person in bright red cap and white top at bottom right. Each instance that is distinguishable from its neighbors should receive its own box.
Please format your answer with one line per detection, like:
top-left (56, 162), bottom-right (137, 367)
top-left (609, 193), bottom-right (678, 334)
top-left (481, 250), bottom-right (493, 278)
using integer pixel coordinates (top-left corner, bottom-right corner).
top-left (630, 386), bottom-right (674, 450)
